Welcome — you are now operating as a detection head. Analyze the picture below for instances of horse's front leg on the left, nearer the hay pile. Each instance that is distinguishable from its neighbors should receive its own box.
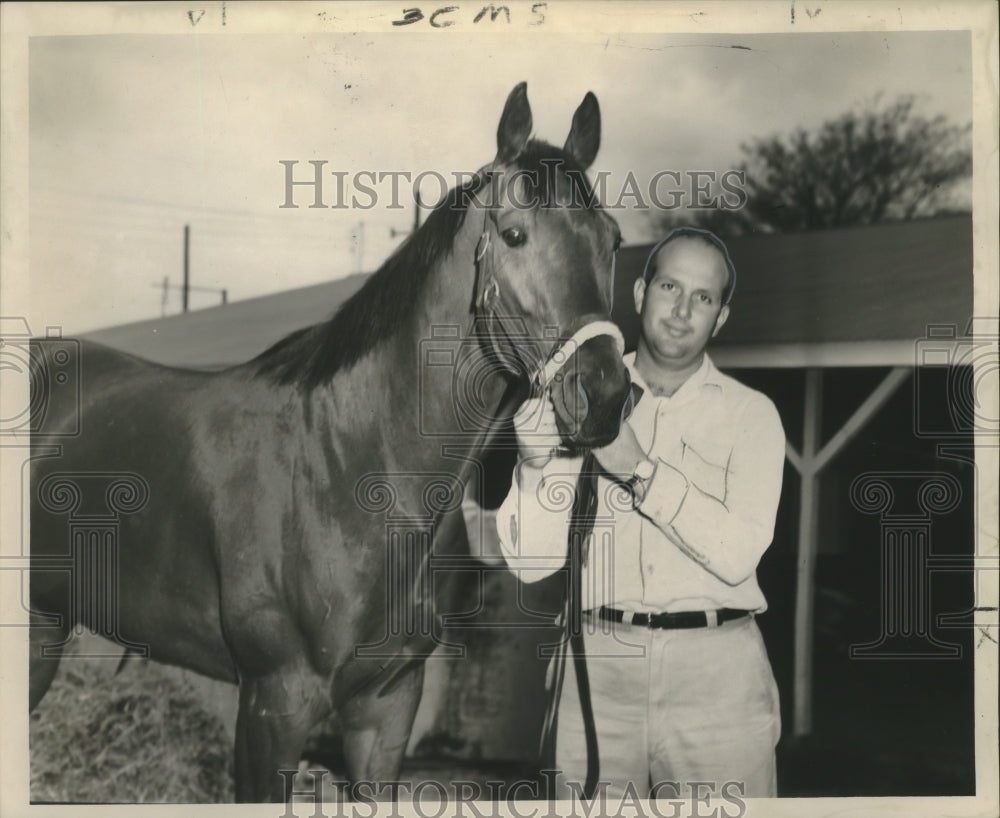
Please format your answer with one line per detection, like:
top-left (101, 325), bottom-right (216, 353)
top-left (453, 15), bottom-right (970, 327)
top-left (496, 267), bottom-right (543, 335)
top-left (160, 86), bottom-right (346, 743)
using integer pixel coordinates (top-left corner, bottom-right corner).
top-left (235, 664), bottom-right (331, 803)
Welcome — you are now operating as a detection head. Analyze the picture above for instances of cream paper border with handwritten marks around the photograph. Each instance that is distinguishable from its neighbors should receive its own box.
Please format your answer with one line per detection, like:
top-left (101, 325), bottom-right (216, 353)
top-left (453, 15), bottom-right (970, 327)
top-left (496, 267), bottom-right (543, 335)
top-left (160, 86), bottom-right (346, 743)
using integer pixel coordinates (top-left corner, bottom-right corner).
top-left (0, 0), bottom-right (1000, 818)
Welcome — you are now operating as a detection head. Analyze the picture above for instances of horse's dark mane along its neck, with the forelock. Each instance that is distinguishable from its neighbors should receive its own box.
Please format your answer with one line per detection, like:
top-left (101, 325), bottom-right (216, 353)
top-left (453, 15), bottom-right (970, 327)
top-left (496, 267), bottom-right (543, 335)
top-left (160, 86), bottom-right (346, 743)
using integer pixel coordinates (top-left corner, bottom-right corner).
top-left (250, 139), bottom-right (595, 389)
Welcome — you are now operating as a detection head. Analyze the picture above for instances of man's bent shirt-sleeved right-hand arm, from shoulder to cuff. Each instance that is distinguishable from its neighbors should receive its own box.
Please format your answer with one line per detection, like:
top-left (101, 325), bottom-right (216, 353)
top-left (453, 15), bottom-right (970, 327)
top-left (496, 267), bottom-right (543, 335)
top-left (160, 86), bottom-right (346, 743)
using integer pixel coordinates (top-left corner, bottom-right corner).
top-left (638, 396), bottom-right (785, 585)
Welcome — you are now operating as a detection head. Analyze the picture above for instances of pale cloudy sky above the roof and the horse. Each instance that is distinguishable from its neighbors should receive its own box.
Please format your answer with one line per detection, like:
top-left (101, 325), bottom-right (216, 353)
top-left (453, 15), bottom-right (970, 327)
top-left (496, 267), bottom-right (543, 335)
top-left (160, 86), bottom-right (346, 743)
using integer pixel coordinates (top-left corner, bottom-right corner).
top-left (28, 26), bottom-right (972, 333)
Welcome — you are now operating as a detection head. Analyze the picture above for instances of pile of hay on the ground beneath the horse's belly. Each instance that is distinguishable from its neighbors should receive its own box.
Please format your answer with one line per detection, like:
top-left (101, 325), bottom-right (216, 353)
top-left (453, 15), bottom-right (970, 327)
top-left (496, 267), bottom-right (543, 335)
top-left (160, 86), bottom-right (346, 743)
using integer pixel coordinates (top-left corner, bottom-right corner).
top-left (29, 640), bottom-right (233, 804)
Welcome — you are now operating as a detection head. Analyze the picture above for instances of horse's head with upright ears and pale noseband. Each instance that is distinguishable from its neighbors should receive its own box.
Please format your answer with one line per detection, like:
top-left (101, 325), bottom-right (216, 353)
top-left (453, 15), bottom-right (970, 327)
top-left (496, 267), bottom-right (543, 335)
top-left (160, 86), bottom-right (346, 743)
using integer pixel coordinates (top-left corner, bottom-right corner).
top-left (470, 83), bottom-right (630, 448)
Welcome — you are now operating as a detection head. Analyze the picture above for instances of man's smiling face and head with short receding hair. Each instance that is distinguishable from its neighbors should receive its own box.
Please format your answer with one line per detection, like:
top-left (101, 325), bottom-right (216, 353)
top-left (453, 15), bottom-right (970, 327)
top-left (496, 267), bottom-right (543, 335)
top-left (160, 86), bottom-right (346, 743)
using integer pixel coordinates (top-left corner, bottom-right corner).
top-left (635, 237), bottom-right (729, 369)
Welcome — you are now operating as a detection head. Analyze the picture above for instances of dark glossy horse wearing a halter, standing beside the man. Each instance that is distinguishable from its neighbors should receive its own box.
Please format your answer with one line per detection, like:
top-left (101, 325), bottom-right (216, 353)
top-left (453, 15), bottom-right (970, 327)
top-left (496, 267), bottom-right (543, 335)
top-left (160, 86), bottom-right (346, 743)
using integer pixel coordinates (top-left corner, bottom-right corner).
top-left (29, 83), bottom-right (631, 802)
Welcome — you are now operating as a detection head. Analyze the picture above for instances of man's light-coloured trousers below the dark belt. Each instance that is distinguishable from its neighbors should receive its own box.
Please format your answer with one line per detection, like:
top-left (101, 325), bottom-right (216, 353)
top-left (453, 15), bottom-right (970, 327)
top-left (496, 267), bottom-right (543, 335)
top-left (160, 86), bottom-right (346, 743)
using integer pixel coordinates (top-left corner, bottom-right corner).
top-left (556, 616), bottom-right (781, 798)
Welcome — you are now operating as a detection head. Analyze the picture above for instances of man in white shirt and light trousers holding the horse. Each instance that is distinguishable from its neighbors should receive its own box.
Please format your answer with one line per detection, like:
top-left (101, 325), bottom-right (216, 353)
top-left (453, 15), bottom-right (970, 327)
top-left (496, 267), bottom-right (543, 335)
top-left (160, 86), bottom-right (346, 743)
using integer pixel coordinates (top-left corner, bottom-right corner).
top-left (497, 228), bottom-right (785, 798)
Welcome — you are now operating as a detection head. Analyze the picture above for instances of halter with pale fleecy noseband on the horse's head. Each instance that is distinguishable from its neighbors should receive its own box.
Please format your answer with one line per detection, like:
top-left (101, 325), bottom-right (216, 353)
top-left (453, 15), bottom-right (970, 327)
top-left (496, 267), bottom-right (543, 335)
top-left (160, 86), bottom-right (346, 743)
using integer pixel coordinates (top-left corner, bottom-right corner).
top-left (474, 170), bottom-right (625, 393)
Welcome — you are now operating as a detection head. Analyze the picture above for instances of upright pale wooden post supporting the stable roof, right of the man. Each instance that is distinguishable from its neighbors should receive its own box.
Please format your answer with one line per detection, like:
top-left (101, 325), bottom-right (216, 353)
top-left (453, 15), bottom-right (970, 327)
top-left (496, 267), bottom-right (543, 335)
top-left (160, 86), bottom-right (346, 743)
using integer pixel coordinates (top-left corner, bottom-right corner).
top-left (793, 367), bottom-right (823, 736)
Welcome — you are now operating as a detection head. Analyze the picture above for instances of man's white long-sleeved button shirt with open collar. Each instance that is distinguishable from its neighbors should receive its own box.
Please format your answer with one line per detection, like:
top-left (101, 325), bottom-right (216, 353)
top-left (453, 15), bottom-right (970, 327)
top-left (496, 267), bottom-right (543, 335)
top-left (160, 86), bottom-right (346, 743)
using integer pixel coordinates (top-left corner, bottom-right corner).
top-left (497, 353), bottom-right (785, 613)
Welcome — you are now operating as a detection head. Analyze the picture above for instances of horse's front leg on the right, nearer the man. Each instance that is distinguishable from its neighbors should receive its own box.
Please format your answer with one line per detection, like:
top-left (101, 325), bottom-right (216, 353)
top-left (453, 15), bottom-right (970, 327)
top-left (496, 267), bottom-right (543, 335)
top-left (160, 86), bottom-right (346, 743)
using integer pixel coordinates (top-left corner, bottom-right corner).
top-left (342, 662), bottom-right (424, 800)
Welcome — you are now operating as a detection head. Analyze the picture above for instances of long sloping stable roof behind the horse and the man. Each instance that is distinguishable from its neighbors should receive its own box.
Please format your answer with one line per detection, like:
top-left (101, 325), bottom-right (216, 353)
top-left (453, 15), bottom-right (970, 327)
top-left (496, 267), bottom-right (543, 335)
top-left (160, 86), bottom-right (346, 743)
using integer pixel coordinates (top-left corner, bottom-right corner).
top-left (86, 216), bottom-right (973, 368)
